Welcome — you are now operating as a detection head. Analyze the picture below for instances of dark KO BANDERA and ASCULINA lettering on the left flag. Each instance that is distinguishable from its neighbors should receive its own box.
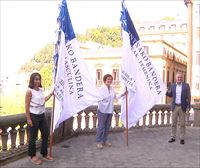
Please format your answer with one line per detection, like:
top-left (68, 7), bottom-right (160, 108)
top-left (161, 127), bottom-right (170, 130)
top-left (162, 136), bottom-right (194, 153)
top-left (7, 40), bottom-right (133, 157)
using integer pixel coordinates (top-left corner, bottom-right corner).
top-left (65, 44), bottom-right (84, 98)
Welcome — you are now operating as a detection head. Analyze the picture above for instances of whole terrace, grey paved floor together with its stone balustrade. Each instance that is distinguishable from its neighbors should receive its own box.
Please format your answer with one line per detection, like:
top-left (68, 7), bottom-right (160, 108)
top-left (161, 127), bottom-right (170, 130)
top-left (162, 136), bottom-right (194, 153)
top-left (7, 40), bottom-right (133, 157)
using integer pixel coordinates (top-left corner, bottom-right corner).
top-left (0, 104), bottom-right (200, 167)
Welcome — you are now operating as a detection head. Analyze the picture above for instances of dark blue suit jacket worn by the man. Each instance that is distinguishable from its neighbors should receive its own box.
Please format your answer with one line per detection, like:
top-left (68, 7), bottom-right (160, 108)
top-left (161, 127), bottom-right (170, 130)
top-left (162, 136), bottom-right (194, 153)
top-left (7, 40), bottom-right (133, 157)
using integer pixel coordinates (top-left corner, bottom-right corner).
top-left (166, 82), bottom-right (191, 111)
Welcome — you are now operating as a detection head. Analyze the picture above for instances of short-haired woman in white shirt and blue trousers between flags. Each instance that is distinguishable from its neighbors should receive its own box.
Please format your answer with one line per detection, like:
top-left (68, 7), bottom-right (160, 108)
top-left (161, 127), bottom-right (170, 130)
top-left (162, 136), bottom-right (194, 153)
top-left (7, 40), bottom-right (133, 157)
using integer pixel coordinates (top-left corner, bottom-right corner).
top-left (96, 74), bottom-right (126, 149)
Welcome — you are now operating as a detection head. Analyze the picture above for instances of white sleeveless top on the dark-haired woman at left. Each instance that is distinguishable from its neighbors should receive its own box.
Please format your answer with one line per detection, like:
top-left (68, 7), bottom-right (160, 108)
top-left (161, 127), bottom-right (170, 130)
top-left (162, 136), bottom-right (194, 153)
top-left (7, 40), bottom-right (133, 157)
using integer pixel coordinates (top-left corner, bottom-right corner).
top-left (29, 88), bottom-right (45, 114)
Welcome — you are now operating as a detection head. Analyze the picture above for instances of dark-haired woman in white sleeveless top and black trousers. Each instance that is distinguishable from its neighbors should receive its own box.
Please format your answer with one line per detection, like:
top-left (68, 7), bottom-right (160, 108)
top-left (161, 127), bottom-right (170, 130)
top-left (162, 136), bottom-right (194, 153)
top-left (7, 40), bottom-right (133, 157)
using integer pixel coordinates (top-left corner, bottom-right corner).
top-left (25, 72), bottom-right (53, 164)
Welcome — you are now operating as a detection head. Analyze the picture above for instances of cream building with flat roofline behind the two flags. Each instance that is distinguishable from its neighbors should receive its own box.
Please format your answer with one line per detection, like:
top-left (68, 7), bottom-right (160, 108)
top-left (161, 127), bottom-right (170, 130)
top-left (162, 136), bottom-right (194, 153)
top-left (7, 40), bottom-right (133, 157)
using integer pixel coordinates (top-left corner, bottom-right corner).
top-left (81, 40), bottom-right (187, 103)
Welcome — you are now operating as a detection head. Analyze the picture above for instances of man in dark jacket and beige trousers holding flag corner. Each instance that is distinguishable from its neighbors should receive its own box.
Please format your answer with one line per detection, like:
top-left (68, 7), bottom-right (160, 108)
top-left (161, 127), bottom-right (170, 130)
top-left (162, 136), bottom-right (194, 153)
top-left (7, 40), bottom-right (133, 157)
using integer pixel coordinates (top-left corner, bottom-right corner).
top-left (166, 72), bottom-right (191, 144)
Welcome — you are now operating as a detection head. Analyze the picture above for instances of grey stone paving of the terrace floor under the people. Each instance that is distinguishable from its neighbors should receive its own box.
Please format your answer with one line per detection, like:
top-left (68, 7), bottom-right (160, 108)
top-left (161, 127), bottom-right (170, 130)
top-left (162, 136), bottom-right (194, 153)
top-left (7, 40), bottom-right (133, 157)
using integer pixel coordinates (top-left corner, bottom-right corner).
top-left (2, 127), bottom-right (200, 168)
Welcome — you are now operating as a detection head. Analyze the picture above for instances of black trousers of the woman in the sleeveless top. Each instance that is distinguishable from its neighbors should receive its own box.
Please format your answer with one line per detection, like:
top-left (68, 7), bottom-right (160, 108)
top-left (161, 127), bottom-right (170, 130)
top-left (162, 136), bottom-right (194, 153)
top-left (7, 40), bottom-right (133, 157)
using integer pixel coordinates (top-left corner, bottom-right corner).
top-left (28, 113), bottom-right (48, 157)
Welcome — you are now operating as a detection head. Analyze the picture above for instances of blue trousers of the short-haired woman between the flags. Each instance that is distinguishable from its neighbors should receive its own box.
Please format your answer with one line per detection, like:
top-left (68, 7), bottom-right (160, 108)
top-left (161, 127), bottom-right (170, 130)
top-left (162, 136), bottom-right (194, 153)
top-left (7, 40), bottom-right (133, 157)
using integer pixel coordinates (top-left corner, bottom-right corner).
top-left (96, 111), bottom-right (112, 143)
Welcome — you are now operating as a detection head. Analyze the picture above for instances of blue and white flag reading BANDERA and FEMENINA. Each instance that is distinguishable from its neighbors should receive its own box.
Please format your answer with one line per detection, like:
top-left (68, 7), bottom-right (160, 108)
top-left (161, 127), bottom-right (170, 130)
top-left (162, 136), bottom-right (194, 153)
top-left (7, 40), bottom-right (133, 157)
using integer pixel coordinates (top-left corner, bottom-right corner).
top-left (120, 1), bottom-right (165, 128)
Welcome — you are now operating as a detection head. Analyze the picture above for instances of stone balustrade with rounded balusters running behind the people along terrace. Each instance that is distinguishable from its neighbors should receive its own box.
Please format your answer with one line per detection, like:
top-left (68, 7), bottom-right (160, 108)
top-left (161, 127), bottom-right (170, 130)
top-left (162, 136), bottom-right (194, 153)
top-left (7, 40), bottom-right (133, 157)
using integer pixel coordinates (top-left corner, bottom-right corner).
top-left (0, 105), bottom-right (200, 163)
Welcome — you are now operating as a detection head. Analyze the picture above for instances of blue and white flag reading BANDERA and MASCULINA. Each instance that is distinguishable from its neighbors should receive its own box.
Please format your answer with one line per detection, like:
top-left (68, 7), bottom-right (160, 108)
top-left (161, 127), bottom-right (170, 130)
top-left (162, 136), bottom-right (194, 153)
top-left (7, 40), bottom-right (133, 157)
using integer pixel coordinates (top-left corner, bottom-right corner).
top-left (53, 0), bottom-right (102, 130)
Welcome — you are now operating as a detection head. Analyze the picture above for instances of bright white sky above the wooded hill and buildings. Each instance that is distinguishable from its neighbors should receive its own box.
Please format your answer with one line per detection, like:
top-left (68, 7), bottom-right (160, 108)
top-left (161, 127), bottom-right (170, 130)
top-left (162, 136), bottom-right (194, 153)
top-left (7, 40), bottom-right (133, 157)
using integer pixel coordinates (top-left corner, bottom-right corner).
top-left (0, 0), bottom-right (187, 76)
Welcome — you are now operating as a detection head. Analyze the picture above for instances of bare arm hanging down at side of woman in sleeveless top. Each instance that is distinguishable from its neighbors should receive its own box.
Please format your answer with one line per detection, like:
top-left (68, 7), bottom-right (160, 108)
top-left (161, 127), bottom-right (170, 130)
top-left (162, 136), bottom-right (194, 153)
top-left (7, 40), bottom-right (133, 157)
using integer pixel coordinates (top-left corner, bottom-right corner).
top-left (25, 90), bottom-right (33, 126)
